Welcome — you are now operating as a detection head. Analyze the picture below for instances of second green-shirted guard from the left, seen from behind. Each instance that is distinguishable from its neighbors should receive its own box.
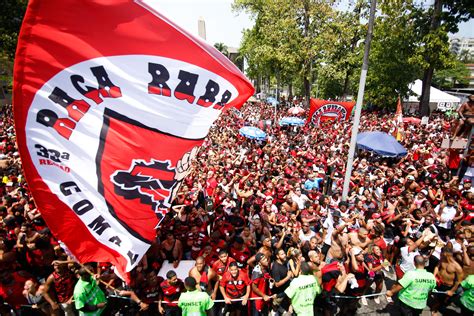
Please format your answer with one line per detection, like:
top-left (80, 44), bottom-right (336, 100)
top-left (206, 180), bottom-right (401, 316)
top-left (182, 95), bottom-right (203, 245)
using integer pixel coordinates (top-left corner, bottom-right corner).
top-left (178, 277), bottom-right (214, 316)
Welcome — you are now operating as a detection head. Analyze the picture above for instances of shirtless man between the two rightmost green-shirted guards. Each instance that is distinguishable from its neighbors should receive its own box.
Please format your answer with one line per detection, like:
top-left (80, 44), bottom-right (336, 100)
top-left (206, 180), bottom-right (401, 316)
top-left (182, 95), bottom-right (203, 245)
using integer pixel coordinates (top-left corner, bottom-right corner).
top-left (431, 244), bottom-right (464, 315)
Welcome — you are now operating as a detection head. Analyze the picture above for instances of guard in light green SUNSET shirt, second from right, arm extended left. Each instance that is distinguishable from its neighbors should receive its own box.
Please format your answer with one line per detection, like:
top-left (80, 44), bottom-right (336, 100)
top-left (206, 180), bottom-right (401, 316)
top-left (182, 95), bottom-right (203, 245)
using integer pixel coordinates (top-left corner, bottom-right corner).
top-left (387, 255), bottom-right (436, 316)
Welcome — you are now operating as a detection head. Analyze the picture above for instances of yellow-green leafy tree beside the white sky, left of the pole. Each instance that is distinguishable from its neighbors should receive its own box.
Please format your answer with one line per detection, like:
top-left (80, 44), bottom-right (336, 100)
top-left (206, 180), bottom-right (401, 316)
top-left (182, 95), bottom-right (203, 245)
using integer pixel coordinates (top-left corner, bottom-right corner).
top-left (234, 0), bottom-right (335, 105)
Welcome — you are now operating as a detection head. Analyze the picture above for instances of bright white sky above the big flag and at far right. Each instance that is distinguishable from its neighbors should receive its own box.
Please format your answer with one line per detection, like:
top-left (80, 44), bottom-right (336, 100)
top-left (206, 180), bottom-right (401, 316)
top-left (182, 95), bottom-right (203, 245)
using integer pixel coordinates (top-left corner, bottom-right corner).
top-left (147, 0), bottom-right (474, 47)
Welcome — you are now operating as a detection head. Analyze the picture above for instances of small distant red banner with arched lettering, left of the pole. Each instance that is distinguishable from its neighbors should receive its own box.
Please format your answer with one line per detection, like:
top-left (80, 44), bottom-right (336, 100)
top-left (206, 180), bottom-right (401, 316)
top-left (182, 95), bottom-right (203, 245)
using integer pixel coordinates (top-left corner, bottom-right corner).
top-left (306, 99), bottom-right (355, 125)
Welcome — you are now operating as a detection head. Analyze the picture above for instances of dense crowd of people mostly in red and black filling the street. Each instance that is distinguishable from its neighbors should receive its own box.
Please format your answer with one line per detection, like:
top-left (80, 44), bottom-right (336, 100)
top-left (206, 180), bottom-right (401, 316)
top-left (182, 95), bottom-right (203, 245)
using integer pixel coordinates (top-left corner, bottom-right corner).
top-left (0, 96), bottom-right (474, 315)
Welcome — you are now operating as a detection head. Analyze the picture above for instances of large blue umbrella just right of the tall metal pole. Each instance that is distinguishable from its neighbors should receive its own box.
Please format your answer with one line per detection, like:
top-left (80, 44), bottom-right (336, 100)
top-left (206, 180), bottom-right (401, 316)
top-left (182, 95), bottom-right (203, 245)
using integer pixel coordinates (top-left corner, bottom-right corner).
top-left (357, 132), bottom-right (407, 157)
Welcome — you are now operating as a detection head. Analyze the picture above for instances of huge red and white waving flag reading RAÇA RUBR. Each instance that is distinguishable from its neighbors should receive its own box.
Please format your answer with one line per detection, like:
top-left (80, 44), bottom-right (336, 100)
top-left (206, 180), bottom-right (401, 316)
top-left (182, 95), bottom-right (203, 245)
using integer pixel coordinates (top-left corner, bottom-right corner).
top-left (14, 0), bottom-right (254, 278)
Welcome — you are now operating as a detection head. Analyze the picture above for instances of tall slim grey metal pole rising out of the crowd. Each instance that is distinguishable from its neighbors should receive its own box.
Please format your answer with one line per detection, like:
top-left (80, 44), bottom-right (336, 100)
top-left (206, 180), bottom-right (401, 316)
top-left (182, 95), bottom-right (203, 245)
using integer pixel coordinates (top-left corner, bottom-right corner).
top-left (342, 0), bottom-right (377, 201)
